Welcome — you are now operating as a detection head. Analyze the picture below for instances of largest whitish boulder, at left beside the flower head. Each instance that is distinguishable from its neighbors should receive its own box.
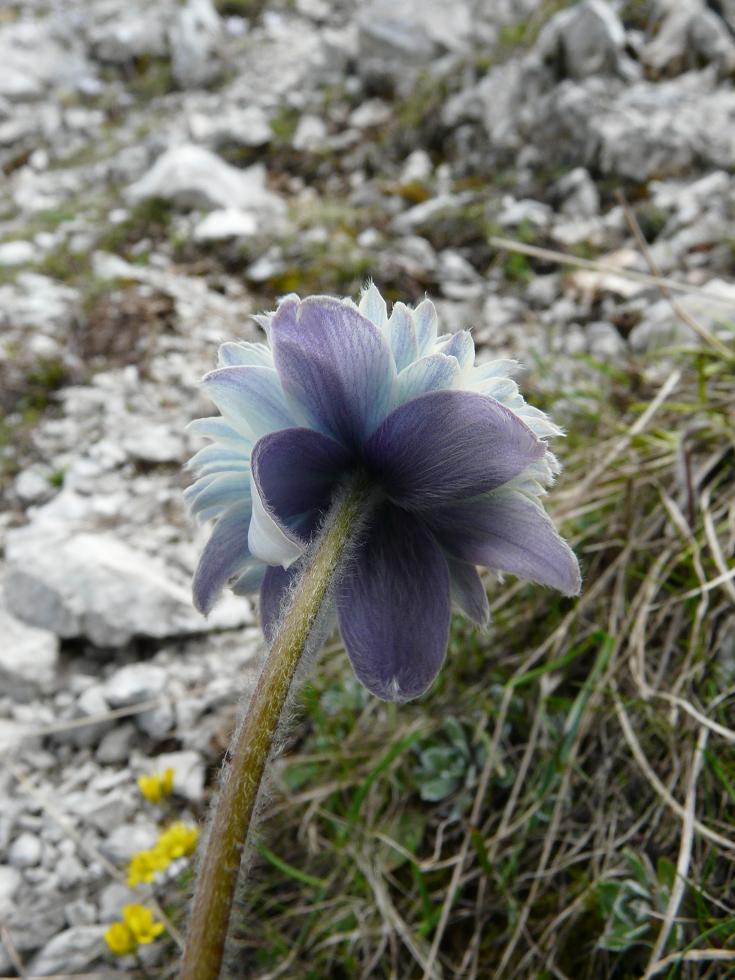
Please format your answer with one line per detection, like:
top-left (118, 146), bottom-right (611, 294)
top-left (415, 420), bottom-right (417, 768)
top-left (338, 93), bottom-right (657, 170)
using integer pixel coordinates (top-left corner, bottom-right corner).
top-left (6, 526), bottom-right (221, 647)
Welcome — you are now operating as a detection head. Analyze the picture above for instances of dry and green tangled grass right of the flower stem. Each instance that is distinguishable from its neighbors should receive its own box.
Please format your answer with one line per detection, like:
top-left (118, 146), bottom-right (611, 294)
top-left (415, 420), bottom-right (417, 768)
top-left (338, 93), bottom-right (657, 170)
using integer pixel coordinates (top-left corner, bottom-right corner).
top-left (191, 334), bottom-right (735, 980)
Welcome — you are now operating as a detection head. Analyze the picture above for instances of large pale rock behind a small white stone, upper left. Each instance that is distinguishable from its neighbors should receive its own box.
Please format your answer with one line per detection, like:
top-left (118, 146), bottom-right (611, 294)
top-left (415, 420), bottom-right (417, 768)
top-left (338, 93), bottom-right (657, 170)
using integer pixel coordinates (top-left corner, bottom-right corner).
top-left (126, 144), bottom-right (284, 215)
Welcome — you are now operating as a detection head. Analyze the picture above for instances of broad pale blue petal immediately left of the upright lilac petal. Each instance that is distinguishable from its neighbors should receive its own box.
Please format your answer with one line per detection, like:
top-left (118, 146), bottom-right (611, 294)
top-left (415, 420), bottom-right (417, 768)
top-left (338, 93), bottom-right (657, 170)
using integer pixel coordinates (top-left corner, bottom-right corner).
top-left (202, 365), bottom-right (294, 439)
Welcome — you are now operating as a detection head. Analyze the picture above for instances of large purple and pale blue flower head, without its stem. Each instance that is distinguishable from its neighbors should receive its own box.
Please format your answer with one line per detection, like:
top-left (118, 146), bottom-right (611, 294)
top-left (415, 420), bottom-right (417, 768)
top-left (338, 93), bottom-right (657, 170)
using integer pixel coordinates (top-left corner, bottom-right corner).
top-left (185, 285), bottom-right (581, 700)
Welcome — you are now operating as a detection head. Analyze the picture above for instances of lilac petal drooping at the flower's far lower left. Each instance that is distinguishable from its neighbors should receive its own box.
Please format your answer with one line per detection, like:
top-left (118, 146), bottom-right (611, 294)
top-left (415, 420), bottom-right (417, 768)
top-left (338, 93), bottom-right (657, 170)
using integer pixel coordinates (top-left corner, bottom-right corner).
top-left (193, 501), bottom-right (250, 616)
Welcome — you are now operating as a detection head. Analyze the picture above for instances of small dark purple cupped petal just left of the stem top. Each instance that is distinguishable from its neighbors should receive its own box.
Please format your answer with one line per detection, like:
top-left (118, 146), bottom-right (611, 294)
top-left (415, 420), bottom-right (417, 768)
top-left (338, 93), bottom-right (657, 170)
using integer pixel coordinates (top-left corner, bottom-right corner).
top-left (251, 429), bottom-right (351, 524)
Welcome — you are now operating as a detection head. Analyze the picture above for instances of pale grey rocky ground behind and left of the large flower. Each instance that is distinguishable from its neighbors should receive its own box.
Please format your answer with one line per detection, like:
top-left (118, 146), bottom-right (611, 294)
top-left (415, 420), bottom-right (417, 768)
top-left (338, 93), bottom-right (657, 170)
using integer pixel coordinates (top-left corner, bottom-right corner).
top-left (0, 0), bottom-right (735, 975)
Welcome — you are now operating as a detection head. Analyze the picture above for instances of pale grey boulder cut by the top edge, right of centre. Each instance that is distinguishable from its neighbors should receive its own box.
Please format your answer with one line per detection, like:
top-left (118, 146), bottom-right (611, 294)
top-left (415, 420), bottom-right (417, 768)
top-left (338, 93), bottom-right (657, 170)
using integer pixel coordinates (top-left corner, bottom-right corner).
top-left (533, 0), bottom-right (640, 81)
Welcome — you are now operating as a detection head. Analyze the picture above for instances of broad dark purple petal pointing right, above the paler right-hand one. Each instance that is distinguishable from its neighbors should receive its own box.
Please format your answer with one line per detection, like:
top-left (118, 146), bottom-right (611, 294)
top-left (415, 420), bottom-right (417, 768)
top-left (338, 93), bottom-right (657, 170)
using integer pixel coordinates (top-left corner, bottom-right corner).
top-left (365, 391), bottom-right (546, 510)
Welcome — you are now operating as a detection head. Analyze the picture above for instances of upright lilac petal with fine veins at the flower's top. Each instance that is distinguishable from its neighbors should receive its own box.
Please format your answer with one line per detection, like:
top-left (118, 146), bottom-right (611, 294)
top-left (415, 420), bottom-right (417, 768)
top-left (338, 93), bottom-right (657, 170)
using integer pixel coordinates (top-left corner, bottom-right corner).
top-left (271, 297), bottom-right (396, 445)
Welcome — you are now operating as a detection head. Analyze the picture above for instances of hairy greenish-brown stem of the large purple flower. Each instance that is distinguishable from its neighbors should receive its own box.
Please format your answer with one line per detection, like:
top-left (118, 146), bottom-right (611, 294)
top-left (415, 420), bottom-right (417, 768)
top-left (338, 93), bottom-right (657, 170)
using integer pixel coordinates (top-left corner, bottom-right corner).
top-left (179, 487), bottom-right (368, 980)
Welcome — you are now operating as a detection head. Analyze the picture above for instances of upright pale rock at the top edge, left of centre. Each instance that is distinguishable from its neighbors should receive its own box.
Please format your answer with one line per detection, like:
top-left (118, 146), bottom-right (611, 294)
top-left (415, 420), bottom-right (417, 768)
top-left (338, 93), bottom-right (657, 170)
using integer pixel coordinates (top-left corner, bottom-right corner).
top-left (169, 0), bottom-right (222, 88)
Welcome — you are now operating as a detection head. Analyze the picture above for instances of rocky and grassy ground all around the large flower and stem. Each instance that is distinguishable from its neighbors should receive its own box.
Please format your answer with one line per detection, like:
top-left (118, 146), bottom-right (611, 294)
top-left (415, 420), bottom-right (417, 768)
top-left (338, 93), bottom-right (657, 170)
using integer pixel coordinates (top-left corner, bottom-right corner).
top-left (0, 0), bottom-right (735, 980)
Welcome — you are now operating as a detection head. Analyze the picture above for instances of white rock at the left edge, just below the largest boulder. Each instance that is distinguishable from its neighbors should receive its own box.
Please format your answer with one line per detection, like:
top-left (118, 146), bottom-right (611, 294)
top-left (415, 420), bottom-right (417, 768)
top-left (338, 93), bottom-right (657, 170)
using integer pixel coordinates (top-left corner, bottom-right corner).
top-left (0, 609), bottom-right (59, 700)
